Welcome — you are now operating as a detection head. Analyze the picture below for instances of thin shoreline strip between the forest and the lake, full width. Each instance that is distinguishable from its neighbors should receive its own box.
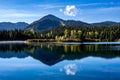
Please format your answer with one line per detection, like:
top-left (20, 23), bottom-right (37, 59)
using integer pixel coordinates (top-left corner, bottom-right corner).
top-left (0, 39), bottom-right (120, 44)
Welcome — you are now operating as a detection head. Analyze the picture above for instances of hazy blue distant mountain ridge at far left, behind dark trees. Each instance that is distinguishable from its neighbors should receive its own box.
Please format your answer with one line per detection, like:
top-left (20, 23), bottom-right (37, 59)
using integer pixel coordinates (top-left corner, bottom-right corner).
top-left (0, 22), bottom-right (28, 30)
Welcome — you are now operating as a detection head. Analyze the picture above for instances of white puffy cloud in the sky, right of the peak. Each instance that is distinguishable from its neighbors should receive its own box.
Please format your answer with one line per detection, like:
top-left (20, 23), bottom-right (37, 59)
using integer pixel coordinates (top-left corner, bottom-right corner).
top-left (59, 5), bottom-right (78, 16)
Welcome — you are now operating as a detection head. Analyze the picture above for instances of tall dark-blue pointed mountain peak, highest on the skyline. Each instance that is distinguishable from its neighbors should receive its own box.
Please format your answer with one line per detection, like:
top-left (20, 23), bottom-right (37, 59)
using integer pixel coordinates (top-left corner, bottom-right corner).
top-left (27, 14), bottom-right (63, 31)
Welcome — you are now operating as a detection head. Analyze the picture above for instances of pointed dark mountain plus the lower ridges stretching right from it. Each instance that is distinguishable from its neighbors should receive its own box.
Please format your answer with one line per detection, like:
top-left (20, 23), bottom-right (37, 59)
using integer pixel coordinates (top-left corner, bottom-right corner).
top-left (26, 14), bottom-right (120, 31)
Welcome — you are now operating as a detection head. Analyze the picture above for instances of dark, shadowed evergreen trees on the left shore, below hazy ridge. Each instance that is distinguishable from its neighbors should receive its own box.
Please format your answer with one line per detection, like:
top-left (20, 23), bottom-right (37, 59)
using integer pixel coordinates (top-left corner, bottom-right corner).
top-left (0, 30), bottom-right (35, 41)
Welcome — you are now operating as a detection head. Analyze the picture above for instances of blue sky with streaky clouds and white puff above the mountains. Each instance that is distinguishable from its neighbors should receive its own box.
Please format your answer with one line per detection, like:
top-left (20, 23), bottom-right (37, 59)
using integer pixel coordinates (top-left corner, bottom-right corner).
top-left (0, 0), bottom-right (120, 23)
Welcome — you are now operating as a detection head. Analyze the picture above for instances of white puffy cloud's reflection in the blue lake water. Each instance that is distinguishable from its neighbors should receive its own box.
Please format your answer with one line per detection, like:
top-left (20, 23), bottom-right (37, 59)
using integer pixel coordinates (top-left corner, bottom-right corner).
top-left (60, 64), bottom-right (77, 75)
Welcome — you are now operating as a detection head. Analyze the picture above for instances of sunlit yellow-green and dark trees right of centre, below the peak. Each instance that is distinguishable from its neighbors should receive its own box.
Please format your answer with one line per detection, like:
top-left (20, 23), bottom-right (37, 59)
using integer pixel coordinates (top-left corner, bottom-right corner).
top-left (37, 26), bottom-right (120, 41)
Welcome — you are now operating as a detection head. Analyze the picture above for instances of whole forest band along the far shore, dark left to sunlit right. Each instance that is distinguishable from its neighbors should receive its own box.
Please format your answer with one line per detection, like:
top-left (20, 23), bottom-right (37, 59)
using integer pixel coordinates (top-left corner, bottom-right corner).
top-left (0, 26), bottom-right (120, 41)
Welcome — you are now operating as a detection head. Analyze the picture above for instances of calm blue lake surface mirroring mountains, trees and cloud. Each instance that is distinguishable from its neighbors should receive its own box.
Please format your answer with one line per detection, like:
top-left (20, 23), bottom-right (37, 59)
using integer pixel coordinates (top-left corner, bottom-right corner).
top-left (0, 42), bottom-right (120, 80)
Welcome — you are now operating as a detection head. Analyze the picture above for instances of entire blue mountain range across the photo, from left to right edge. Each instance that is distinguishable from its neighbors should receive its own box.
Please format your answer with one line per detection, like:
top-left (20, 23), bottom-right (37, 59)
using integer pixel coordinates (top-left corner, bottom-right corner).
top-left (0, 14), bottom-right (120, 31)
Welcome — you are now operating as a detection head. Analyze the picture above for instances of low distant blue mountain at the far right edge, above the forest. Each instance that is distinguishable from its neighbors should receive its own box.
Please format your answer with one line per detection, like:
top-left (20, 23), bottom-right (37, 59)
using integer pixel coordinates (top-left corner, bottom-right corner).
top-left (91, 21), bottom-right (120, 26)
